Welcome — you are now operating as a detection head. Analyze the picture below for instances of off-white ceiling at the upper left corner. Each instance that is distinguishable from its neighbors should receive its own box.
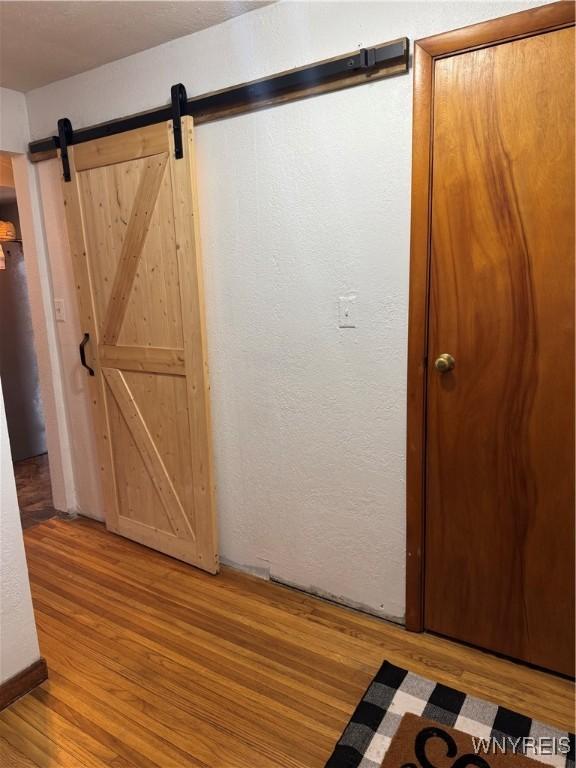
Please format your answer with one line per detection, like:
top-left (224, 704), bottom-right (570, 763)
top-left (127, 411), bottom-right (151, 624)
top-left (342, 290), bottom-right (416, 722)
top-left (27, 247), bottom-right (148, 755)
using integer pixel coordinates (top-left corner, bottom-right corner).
top-left (0, 0), bottom-right (273, 91)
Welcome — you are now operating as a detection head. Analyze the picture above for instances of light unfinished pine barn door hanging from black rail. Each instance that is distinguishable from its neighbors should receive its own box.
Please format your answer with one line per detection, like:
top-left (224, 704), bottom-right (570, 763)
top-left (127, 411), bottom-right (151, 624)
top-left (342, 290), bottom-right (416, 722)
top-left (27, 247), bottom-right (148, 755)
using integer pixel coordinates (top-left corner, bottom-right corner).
top-left (62, 117), bottom-right (218, 573)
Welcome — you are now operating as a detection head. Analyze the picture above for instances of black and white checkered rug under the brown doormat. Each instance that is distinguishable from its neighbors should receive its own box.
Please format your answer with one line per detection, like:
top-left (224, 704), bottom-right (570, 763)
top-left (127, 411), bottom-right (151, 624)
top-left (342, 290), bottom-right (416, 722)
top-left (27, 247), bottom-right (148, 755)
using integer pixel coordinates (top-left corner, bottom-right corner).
top-left (326, 661), bottom-right (575, 768)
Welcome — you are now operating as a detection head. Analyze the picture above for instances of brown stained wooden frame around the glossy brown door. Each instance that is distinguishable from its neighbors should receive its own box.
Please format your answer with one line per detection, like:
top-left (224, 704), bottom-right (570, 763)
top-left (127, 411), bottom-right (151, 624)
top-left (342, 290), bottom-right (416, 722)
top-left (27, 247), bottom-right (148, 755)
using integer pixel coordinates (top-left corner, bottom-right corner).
top-left (406, 1), bottom-right (575, 632)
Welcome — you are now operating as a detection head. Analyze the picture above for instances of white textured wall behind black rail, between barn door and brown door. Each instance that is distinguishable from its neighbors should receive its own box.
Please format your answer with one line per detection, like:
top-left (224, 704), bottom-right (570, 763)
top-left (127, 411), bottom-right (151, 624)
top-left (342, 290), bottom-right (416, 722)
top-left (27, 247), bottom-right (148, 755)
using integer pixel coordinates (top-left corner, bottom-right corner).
top-left (28, 0), bottom-right (542, 620)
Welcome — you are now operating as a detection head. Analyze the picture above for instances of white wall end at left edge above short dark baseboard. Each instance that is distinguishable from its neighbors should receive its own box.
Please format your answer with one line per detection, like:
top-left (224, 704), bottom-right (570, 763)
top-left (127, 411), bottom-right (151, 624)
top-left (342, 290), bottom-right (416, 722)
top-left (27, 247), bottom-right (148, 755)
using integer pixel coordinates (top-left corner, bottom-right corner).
top-left (0, 386), bottom-right (40, 684)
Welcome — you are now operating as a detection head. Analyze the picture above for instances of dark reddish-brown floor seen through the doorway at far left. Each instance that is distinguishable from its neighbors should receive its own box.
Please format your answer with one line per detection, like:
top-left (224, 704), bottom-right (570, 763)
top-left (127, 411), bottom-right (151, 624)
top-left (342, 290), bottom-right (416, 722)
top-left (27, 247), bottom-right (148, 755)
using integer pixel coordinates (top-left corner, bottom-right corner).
top-left (14, 453), bottom-right (58, 528)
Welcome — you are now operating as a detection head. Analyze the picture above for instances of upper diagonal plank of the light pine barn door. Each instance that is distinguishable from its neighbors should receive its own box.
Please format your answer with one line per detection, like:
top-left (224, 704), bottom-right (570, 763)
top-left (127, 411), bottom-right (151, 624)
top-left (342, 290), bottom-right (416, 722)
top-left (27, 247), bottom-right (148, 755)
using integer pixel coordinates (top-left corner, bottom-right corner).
top-left (103, 153), bottom-right (168, 345)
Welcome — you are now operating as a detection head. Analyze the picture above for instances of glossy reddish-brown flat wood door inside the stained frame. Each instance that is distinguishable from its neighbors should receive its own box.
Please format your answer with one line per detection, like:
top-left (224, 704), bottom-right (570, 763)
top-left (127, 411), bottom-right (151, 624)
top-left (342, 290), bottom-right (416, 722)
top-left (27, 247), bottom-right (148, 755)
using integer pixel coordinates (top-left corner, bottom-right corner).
top-left (425, 28), bottom-right (575, 674)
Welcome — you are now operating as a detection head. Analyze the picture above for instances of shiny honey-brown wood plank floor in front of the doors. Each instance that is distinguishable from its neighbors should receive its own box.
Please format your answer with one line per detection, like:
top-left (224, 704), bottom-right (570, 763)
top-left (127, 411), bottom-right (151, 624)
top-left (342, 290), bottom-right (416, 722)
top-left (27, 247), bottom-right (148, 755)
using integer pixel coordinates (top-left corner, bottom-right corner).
top-left (0, 519), bottom-right (574, 768)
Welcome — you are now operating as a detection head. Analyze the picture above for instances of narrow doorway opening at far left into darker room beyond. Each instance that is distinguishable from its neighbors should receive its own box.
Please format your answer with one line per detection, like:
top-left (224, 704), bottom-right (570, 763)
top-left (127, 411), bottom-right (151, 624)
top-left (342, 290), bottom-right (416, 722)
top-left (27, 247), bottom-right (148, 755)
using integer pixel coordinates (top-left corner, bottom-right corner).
top-left (0, 153), bottom-right (57, 528)
